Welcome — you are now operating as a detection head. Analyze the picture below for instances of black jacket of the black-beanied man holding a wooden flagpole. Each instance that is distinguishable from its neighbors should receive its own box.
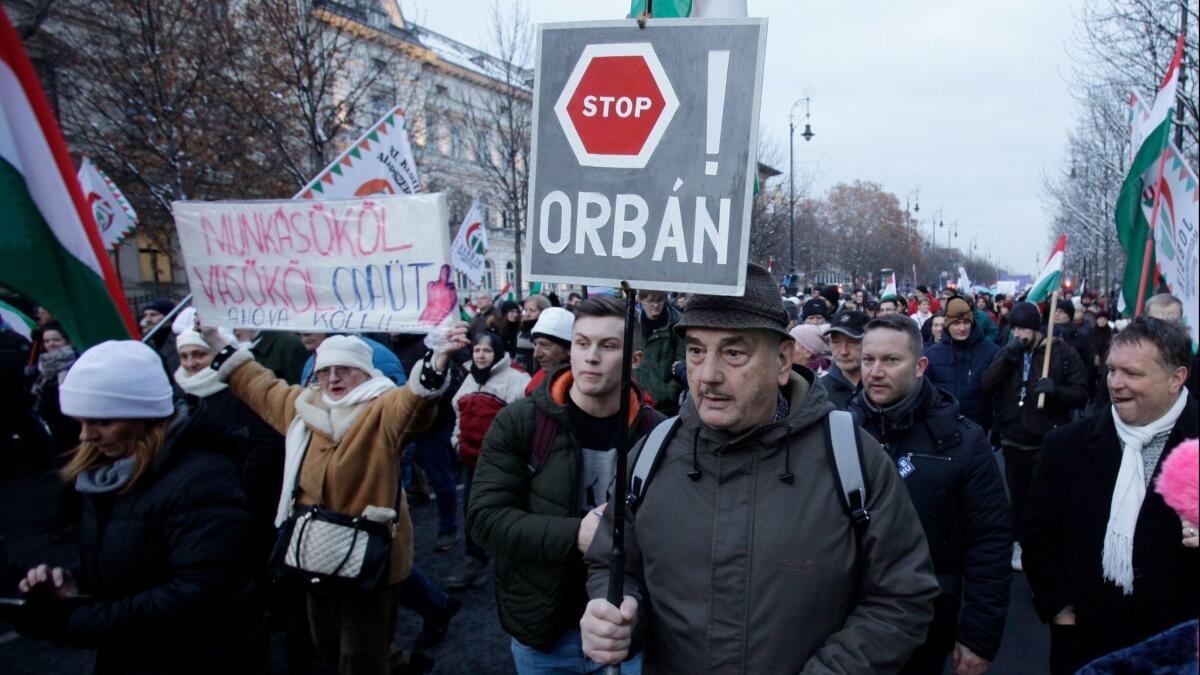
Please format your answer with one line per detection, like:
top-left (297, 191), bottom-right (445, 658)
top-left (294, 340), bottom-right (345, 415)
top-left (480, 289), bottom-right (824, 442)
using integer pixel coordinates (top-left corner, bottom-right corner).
top-left (980, 338), bottom-right (1088, 448)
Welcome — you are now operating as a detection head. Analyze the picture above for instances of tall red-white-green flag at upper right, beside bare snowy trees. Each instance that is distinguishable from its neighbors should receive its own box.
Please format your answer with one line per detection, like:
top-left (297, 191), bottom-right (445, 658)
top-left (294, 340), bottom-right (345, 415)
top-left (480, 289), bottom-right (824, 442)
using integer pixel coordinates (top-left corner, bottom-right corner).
top-left (1115, 35), bottom-right (1183, 315)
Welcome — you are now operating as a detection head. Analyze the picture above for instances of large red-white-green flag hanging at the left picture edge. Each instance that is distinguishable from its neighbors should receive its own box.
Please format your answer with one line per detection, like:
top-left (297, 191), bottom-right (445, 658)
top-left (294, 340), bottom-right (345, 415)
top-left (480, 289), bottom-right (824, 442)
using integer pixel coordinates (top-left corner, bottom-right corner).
top-left (0, 10), bottom-right (137, 347)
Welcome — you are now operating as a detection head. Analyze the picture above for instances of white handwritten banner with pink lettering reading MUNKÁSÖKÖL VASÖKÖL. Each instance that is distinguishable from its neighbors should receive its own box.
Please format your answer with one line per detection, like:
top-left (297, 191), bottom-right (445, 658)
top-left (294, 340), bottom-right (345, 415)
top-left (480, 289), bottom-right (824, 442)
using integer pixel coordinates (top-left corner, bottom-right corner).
top-left (173, 193), bottom-right (458, 333)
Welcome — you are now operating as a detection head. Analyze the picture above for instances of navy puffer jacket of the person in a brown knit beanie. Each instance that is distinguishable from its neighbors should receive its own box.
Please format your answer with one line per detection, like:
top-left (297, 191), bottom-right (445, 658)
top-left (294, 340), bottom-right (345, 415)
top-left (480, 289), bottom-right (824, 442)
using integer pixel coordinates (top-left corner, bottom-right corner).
top-left (925, 325), bottom-right (1000, 430)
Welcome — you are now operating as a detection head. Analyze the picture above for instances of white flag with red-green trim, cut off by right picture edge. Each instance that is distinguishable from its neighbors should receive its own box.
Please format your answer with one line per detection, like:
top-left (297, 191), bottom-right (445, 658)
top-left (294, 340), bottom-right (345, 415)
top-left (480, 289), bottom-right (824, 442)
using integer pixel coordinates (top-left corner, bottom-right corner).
top-left (1144, 143), bottom-right (1200, 345)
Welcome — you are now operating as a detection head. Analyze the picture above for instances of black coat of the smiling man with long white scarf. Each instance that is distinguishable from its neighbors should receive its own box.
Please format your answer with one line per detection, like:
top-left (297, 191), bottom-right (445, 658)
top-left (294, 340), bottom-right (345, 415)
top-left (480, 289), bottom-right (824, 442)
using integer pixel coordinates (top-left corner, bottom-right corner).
top-left (1021, 396), bottom-right (1200, 651)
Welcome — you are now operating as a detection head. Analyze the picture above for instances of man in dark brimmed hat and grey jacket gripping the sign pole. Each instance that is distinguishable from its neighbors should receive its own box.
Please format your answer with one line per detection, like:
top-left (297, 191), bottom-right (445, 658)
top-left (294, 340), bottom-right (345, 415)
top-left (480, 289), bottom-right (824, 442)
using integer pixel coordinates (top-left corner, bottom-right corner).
top-left (580, 264), bottom-right (938, 674)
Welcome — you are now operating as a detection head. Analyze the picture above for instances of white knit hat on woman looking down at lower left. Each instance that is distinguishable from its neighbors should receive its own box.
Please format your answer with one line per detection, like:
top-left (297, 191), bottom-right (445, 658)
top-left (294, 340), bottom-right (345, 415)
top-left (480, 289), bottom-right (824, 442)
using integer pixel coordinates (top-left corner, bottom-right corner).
top-left (59, 340), bottom-right (175, 419)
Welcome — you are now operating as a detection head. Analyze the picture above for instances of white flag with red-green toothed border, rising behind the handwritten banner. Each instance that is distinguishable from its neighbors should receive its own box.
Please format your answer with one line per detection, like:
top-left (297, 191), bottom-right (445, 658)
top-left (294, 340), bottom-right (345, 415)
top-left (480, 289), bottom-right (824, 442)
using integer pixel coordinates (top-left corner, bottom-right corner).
top-left (293, 107), bottom-right (421, 199)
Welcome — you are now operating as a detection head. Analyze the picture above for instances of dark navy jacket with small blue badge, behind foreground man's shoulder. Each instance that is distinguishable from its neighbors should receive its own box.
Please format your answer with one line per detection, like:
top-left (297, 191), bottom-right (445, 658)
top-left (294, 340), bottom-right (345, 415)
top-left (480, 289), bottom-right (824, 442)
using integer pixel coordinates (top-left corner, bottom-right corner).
top-left (848, 378), bottom-right (1013, 661)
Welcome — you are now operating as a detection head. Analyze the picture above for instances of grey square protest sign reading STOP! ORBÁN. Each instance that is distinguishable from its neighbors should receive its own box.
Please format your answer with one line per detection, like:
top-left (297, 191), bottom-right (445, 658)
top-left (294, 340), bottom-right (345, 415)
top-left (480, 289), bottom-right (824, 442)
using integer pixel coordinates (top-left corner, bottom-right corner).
top-left (524, 19), bottom-right (767, 294)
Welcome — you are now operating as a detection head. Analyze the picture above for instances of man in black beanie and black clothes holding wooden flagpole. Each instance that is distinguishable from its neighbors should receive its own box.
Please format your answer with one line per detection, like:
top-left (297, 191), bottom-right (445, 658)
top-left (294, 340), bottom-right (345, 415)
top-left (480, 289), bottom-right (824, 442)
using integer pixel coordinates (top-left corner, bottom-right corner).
top-left (980, 303), bottom-right (1087, 571)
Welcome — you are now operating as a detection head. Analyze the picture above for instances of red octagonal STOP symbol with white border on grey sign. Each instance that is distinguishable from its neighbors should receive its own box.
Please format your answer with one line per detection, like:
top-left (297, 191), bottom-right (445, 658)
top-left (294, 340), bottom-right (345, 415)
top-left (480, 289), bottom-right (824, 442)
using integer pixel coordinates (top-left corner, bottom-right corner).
top-left (554, 42), bottom-right (679, 168)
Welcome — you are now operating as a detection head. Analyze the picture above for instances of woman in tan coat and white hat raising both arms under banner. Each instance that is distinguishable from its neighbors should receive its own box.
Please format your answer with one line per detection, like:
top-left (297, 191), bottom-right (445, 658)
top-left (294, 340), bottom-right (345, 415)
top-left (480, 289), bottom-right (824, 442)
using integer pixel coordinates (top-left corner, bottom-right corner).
top-left (202, 323), bottom-right (469, 673)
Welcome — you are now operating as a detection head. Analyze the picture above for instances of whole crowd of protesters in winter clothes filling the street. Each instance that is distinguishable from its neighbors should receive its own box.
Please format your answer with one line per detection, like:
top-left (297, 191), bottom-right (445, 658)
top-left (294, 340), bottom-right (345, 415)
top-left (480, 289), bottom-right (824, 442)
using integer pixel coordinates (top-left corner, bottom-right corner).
top-left (0, 269), bottom-right (1200, 675)
